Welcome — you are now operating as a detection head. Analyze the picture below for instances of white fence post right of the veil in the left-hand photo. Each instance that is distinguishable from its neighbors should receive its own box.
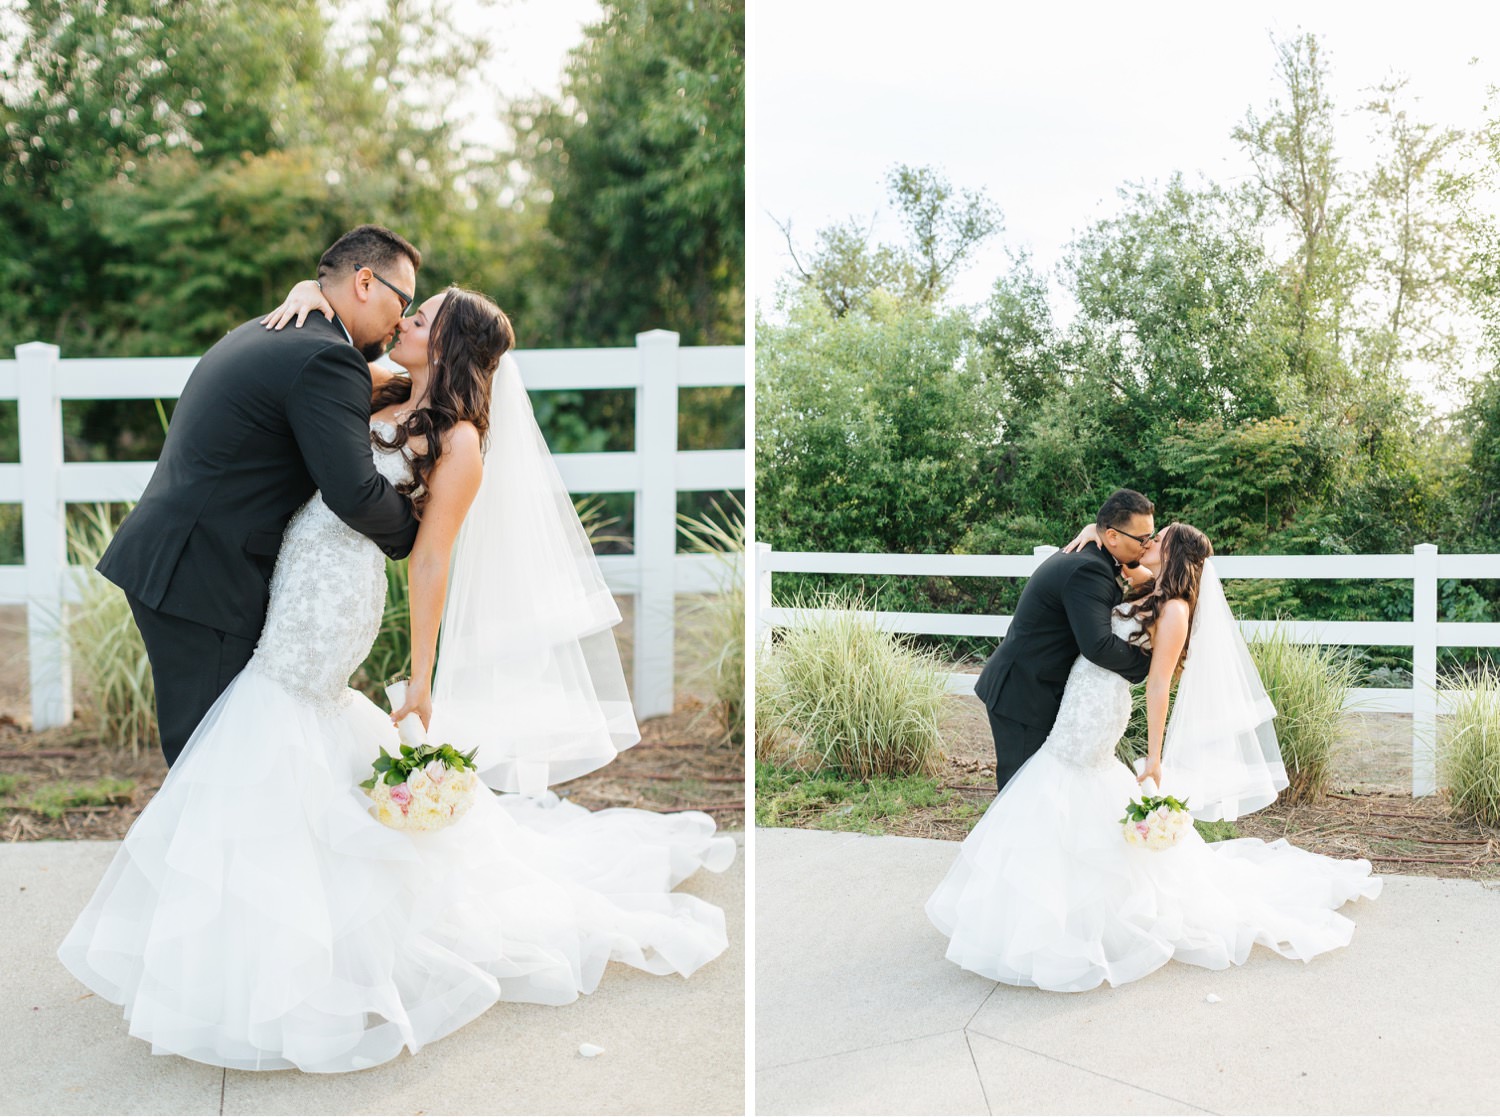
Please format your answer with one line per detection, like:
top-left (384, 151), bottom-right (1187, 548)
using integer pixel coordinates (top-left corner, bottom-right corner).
top-left (635, 330), bottom-right (678, 718)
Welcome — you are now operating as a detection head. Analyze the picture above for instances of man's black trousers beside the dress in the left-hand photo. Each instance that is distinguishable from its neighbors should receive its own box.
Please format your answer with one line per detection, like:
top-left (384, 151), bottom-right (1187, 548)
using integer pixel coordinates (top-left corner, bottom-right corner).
top-left (125, 594), bottom-right (255, 768)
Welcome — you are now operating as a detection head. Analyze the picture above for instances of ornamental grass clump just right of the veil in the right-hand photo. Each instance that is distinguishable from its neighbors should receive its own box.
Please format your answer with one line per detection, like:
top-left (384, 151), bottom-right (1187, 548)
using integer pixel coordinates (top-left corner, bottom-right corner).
top-left (1250, 625), bottom-right (1359, 802)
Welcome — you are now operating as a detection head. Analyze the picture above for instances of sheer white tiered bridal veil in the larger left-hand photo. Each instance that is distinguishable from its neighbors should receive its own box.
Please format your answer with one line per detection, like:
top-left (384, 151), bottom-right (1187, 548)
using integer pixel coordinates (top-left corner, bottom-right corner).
top-left (429, 354), bottom-right (641, 795)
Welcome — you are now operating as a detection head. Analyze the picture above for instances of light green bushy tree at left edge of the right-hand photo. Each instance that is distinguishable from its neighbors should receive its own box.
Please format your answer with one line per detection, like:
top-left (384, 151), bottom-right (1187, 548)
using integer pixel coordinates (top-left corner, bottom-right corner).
top-left (756, 292), bottom-right (1001, 552)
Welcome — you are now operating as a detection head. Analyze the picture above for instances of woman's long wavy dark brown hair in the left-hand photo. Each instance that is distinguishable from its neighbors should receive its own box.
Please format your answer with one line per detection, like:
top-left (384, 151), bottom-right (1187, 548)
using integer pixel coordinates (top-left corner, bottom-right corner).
top-left (371, 286), bottom-right (516, 517)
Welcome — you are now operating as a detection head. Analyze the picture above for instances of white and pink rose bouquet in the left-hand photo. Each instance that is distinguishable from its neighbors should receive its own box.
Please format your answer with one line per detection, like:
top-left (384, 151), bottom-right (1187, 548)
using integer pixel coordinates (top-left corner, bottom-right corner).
top-left (360, 682), bottom-right (479, 831)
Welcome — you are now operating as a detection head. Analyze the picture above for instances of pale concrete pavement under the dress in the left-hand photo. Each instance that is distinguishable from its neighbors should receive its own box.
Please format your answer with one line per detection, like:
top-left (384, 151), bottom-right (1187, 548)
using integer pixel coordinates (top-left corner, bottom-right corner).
top-left (0, 834), bottom-right (746, 1114)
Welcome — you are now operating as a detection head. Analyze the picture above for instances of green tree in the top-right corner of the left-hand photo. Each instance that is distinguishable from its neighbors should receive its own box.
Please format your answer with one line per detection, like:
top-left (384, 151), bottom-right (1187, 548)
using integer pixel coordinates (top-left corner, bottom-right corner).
top-left (510, 0), bottom-right (746, 345)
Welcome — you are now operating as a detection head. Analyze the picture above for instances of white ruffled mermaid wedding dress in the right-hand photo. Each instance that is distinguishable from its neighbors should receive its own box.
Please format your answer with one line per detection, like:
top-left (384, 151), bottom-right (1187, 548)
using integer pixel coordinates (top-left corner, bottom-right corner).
top-left (927, 613), bottom-right (1382, 993)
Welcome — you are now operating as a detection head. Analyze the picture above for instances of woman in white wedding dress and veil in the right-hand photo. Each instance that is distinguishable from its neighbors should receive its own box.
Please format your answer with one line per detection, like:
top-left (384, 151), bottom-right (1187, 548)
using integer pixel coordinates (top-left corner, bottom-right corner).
top-left (927, 523), bottom-right (1382, 993)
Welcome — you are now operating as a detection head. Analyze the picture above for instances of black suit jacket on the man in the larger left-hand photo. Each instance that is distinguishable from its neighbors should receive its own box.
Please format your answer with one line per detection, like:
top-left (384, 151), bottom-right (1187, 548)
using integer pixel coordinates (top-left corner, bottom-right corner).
top-left (99, 315), bottom-right (417, 639)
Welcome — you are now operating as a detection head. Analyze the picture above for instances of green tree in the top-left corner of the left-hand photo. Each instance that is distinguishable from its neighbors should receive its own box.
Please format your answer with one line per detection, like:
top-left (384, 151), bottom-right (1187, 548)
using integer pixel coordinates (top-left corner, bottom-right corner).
top-left (0, 0), bottom-right (334, 344)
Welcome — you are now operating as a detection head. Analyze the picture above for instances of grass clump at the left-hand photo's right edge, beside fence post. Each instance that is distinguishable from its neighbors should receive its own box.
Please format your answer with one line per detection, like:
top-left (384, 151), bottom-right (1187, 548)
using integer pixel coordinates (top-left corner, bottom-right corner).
top-left (678, 493), bottom-right (746, 745)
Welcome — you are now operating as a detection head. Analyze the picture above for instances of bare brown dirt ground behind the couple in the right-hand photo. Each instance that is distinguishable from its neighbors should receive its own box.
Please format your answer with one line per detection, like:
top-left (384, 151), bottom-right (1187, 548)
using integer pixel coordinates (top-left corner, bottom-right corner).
top-left (888, 697), bottom-right (1500, 880)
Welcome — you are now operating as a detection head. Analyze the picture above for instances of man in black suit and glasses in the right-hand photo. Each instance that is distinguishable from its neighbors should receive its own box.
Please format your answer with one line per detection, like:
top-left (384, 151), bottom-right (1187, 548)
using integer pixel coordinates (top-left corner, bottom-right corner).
top-left (974, 489), bottom-right (1157, 790)
